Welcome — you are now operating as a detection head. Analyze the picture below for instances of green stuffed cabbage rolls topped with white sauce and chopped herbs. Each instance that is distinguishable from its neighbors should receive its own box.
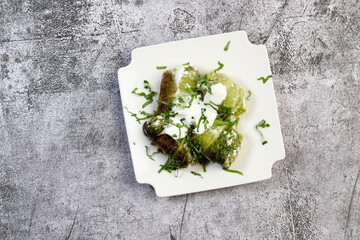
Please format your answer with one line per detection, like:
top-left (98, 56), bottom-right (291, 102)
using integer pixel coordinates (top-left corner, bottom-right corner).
top-left (143, 64), bottom-right (246, 171)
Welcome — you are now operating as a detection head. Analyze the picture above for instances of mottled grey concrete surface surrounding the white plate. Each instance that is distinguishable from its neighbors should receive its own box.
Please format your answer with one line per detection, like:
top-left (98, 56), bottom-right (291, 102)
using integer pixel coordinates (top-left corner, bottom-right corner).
top-left (0, 0), bottom-right (360, 240)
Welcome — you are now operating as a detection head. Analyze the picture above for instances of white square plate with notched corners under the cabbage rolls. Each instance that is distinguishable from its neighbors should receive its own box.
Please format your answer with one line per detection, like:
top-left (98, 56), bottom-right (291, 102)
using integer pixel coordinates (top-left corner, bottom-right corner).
top-left (118, 31), bottom-right (285, 197)
